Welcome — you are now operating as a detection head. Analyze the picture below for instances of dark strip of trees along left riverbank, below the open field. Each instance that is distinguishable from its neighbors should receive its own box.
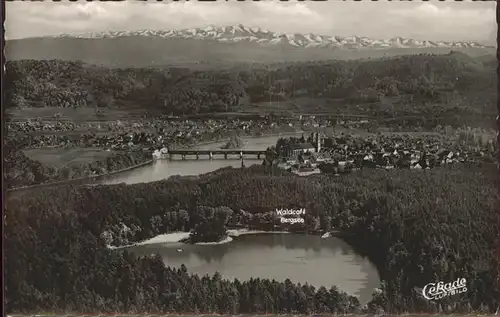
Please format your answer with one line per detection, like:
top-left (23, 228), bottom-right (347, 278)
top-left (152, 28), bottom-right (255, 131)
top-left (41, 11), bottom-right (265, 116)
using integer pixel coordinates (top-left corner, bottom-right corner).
top-left (3, 141), bottom-right (152, 189)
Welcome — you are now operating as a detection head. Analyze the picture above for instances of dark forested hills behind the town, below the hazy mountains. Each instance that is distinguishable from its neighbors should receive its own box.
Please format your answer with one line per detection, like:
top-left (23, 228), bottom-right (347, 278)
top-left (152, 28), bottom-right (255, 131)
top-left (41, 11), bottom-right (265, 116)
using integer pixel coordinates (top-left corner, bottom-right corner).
top-left (5, 52), bottom-right (496, 125)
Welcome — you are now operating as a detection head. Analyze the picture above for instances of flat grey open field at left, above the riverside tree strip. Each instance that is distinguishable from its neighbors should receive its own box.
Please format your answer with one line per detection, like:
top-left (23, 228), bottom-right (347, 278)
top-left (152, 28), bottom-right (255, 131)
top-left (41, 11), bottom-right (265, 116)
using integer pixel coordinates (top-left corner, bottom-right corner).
top-left (23, 148), bottom-right (116, 168)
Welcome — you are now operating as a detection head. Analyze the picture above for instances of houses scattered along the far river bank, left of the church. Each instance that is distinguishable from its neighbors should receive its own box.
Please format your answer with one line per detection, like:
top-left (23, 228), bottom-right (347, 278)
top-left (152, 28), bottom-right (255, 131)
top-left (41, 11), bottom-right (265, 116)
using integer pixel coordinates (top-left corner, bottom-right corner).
top-left (7, 119), bottom-right (324, 149)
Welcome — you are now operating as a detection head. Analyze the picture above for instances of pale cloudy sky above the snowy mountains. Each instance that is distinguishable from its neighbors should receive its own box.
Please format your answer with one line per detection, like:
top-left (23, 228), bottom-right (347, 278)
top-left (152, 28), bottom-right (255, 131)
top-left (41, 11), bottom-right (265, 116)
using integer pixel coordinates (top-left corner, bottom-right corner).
top-left (5, 0), bottom-right (497, 45)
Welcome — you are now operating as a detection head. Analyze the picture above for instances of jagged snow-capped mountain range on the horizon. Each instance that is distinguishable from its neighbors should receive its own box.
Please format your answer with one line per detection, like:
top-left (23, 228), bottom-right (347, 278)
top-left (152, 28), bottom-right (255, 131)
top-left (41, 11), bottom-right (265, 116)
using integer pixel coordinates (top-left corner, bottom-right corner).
top-left (56, 24), bottom-right (488, 49)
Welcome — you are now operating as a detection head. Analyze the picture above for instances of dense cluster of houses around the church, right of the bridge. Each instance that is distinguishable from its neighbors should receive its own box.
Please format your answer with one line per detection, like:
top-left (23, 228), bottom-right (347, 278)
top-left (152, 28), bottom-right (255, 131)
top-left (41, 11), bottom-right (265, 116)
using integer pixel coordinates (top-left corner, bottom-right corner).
top-left (277, 134), bottom-right (495, 175)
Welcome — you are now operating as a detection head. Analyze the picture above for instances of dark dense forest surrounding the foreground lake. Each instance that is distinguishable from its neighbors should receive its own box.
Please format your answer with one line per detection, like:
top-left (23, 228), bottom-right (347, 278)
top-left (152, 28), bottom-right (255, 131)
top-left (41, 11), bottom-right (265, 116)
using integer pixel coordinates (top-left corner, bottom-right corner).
top-left (4, 165), bottom-right (500, 313)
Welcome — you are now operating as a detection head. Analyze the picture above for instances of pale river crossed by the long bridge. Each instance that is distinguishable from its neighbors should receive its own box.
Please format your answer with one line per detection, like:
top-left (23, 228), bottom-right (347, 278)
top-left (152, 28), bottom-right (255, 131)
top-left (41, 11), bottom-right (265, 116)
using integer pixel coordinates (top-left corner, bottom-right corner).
top-left (102, 133), bottom-right (298, 184)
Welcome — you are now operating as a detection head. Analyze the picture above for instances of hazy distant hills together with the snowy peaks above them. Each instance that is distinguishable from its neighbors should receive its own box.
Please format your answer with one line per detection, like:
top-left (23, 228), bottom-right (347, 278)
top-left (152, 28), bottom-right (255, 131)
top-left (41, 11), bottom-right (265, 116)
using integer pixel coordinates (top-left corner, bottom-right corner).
top-left (5, 25), bottom-right (495, 68)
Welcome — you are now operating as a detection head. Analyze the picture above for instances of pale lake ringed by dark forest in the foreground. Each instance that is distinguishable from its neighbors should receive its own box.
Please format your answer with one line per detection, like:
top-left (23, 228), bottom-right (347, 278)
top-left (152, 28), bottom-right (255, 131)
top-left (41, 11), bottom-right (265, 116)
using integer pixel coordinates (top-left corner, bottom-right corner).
top-left (129, 233), bottom-right (380, 304)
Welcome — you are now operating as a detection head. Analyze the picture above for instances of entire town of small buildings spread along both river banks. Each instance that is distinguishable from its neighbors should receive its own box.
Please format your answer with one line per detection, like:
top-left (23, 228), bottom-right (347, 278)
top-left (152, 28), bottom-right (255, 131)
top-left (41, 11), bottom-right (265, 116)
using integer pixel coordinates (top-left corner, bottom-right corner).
top-left (7, 116), bottom-right (497, 180)
